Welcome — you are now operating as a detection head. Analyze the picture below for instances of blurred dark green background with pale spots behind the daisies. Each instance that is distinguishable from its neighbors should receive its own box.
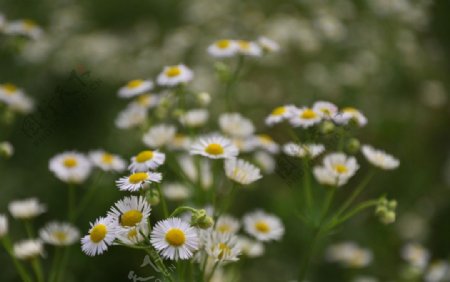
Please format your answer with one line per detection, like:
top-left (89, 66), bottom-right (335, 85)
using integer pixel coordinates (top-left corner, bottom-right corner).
top-left (0, 0), bottom-right (450, 281)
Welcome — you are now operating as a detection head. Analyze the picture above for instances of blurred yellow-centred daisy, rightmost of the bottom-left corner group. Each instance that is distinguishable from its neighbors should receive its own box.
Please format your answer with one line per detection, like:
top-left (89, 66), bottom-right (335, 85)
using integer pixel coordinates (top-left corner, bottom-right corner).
top-left (39, 221), bottom-right (80, 246)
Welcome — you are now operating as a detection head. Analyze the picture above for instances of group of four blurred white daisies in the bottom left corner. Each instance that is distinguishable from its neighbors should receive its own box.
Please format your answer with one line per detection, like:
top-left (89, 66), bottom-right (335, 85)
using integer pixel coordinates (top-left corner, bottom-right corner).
top-left (0, 198), bottom-right (80, 260)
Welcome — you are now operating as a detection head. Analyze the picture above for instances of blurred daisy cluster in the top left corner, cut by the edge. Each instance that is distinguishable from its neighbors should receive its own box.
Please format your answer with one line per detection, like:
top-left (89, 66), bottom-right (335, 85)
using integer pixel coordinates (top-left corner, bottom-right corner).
top-left (0, 13), bottom-right (43, 39)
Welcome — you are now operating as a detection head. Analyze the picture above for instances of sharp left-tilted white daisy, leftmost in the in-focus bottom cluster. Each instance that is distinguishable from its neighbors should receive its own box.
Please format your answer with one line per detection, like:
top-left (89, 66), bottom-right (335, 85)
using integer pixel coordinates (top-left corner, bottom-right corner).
top-left (81, 217), bottom-right (117, 256)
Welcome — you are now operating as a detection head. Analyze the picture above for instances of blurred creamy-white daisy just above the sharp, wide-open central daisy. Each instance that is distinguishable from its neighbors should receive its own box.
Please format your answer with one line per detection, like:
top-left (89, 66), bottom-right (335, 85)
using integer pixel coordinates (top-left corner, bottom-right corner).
top-left (219, 113), bottom-right (255, 138)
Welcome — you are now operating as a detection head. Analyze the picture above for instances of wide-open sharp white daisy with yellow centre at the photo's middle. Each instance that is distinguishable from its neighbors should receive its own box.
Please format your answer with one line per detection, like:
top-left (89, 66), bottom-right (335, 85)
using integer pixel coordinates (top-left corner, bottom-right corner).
top-left (190, 135), bottom-right (239, 159)
